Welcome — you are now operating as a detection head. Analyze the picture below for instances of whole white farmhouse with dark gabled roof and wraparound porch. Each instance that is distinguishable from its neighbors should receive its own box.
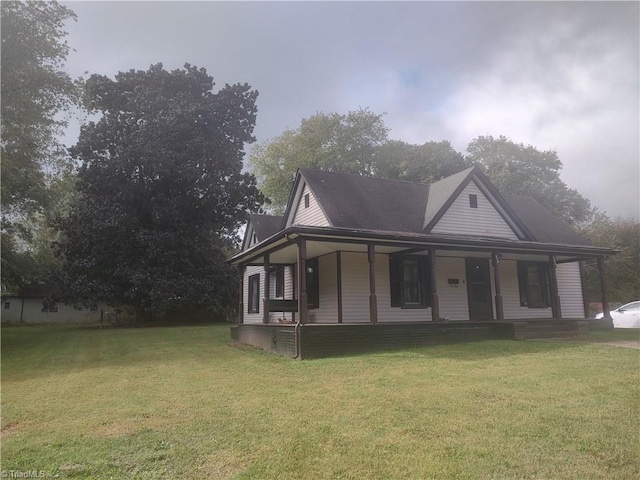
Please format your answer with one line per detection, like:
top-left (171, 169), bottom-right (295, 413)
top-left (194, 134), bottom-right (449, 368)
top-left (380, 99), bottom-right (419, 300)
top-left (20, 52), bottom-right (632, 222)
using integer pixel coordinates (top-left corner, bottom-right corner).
top-left (230, 167), bottom-right (615, 358)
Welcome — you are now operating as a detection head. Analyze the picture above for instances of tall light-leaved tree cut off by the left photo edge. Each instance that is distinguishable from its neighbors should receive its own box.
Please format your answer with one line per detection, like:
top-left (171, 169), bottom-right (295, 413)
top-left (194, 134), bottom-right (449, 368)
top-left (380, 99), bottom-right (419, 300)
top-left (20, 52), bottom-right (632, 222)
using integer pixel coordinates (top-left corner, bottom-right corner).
top-left (0, 1), bottom-right (79, 288)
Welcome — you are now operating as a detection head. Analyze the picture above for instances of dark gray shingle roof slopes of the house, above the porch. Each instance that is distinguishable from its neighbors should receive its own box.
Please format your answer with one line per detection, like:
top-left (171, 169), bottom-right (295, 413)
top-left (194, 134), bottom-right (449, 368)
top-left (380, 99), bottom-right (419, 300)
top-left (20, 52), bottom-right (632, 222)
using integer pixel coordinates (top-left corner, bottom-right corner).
top-left (251, 168), bottom-right (590, 245)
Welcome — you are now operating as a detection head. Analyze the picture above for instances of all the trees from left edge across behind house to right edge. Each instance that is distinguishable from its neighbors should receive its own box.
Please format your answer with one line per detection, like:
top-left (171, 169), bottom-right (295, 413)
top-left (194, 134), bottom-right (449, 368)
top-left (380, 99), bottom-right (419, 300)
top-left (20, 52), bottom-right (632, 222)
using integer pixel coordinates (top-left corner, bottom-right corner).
top-left (1, 2), bottom-right (640, 318)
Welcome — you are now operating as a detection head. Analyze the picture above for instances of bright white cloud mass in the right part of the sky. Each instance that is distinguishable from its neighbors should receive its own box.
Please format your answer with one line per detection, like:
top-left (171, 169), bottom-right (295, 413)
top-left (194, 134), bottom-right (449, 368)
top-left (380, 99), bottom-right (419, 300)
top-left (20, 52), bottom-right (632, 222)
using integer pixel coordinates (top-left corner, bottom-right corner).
top-left (382, 2), bottom-right (640, 218)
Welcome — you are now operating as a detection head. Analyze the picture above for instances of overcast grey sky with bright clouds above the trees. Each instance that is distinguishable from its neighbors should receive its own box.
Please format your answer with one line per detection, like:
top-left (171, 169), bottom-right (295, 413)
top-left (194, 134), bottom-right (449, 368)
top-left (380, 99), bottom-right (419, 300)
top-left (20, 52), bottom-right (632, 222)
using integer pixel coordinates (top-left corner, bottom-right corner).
top-left (65, 2), bottom-right (640, 218)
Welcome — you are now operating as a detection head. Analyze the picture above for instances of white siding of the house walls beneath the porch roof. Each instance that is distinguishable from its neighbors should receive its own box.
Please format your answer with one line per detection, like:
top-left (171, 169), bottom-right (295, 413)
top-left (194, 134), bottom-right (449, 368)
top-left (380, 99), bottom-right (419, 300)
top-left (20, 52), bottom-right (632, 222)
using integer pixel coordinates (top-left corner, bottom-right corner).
top-left (243, 252), bottom-right (584, 323)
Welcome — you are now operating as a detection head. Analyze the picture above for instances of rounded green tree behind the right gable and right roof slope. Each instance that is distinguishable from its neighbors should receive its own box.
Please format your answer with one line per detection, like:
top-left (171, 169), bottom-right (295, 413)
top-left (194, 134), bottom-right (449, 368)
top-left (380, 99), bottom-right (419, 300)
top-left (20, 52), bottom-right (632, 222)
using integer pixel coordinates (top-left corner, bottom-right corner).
top-left (467, 136), bottom-right (592, 225)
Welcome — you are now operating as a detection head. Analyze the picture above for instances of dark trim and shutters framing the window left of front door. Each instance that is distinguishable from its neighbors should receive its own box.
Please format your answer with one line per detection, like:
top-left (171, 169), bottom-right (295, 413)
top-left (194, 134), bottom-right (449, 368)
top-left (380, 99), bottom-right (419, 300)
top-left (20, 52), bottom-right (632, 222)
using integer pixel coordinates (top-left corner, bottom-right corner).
top-left (389, 255), bottom-right (433, 309)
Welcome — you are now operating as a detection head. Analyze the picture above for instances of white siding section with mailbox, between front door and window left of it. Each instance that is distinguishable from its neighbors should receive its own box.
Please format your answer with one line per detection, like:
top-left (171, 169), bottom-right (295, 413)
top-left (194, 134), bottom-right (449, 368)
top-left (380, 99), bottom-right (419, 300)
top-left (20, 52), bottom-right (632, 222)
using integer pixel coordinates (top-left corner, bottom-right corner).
top-left (436, 257), bottom-right (469, 321)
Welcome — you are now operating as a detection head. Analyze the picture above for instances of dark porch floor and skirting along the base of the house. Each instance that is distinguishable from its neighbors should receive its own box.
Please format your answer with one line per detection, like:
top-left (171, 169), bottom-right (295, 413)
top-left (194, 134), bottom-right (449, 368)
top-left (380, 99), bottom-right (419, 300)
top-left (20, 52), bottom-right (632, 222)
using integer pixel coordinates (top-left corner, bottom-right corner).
top-left (231, 319), bottom-right (606, 359)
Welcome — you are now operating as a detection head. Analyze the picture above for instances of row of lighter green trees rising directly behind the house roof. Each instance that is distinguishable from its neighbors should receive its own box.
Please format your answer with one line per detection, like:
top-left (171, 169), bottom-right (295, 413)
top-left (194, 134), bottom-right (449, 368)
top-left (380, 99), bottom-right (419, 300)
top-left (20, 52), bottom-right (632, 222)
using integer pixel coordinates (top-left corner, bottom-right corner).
top-left (249, 108), bottom-right (594, 225)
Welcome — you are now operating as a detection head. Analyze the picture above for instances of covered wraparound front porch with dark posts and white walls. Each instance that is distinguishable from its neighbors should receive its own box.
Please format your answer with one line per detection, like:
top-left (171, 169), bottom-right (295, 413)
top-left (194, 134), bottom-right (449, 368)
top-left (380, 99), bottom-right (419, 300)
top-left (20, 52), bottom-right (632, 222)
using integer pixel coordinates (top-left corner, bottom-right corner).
top-left (234, 227), bottom-right (611, 358)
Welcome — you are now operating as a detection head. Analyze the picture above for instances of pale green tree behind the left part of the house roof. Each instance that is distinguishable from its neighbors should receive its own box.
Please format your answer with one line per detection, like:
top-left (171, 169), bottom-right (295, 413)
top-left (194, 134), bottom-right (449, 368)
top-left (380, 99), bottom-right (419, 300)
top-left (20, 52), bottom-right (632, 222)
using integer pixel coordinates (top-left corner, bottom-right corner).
top-left (249, 109), bottom-right (388, 213)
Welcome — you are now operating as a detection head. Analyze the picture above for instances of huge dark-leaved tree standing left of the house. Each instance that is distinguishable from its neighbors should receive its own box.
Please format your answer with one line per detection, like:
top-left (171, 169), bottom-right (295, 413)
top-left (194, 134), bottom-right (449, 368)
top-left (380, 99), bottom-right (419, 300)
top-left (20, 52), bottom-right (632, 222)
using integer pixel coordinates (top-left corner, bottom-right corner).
top-left (58, 64), bottom-right (264, 317)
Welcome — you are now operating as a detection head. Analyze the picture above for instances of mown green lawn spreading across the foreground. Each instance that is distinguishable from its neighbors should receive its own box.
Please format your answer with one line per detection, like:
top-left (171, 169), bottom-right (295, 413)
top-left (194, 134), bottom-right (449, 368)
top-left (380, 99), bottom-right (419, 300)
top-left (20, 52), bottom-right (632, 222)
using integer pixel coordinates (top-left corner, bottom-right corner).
top-left (2, 326), bottom-right (640, 479)
